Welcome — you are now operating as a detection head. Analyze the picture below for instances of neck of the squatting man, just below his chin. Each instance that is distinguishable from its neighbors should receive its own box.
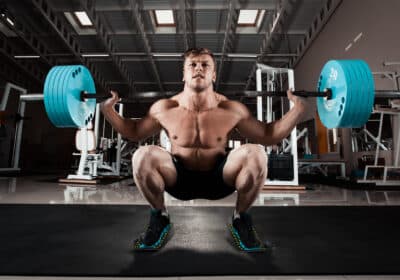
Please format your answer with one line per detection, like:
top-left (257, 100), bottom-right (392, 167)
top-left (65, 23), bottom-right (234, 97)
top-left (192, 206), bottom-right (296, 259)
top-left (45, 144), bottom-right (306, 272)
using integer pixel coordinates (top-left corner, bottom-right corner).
top-left (182, 87), bottom-right (218, 112)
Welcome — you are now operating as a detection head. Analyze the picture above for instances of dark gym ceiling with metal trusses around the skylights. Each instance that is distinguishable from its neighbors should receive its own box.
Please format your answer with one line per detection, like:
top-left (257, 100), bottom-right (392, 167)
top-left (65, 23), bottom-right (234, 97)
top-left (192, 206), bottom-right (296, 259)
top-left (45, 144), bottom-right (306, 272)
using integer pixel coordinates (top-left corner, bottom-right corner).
top-left (0, 0), bottom-right (334, 114)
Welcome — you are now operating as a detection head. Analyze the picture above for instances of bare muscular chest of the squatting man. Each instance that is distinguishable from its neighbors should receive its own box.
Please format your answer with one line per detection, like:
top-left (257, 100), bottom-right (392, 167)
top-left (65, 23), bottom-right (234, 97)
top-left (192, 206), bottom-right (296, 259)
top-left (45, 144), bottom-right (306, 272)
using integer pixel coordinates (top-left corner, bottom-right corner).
top-left (160, 108), bottom-right (237, 149)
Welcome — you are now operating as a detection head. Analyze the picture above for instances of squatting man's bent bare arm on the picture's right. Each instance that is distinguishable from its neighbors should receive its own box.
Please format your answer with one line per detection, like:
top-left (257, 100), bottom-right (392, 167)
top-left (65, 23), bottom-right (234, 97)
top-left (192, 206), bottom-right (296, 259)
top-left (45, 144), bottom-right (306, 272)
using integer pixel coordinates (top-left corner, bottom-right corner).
top-left (236, 91), bottom-right (309, 145)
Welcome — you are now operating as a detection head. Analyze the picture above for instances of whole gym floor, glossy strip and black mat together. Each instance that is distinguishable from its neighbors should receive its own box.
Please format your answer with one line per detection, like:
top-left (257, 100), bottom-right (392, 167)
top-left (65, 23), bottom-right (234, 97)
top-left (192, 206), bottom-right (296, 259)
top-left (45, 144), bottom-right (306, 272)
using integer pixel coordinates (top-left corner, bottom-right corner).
top-left (0, 176), bottom-right (400, 279)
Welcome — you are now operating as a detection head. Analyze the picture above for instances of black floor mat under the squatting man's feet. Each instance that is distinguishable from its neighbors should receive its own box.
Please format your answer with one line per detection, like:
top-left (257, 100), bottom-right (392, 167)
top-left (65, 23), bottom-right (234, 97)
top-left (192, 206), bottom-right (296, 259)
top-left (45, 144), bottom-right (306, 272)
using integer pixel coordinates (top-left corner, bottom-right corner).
top-left (0, 204), bottom-right (400, 276)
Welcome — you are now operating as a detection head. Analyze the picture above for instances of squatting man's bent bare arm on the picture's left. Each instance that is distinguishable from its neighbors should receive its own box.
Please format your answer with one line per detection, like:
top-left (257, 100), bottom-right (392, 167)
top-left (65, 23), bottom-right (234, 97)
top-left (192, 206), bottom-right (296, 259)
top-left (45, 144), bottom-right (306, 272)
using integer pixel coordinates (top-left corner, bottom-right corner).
top-left (100, 91), bottom-right (161, 141)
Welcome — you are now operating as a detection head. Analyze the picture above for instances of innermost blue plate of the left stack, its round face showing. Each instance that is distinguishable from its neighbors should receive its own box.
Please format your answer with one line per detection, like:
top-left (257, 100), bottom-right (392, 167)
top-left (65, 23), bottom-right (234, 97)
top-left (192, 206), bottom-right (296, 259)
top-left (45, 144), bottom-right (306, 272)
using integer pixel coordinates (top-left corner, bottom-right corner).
top-left (64, 65), bottom-right (96, 127)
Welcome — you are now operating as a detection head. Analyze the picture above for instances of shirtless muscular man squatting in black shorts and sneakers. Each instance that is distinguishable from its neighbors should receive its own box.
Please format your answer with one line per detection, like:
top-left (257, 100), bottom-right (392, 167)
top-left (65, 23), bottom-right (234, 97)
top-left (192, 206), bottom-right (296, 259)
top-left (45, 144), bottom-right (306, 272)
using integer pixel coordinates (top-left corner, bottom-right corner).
top-left (101, 48), bottom-right (307, 251)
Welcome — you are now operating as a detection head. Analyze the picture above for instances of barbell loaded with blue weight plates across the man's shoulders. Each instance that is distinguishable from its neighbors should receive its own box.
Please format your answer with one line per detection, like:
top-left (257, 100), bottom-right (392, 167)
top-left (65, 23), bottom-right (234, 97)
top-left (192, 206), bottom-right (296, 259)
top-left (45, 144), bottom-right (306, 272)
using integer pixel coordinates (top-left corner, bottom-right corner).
top-left (43, 60), bottom-right (400, 128)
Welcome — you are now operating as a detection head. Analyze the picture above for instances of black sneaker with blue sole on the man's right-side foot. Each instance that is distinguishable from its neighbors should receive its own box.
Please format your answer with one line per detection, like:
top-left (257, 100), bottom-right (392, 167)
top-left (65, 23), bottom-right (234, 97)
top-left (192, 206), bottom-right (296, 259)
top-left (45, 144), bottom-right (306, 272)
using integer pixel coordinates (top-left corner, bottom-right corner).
top-left (228, 213), bottom-right (267, 252)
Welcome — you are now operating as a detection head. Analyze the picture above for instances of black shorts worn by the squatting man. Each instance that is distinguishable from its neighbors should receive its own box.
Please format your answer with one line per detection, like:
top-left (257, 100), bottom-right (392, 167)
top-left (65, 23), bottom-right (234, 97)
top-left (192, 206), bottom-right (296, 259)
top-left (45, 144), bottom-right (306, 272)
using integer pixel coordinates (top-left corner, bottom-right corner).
top-left (165, 155), bottom-right (236, 200)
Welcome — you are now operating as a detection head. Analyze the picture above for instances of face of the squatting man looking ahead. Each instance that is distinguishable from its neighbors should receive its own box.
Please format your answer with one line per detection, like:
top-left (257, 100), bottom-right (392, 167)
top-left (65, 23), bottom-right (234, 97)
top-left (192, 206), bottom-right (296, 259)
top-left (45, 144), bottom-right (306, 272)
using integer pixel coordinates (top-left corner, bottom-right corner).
top-left (183, 54), bottom-right (216, 92)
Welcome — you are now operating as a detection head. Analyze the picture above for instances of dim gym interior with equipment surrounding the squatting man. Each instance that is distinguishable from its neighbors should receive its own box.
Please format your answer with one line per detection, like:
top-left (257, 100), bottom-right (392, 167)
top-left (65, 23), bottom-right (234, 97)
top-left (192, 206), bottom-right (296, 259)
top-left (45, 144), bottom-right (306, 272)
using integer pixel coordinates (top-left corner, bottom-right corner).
top-left (0, 0), bottom-right (400, 280)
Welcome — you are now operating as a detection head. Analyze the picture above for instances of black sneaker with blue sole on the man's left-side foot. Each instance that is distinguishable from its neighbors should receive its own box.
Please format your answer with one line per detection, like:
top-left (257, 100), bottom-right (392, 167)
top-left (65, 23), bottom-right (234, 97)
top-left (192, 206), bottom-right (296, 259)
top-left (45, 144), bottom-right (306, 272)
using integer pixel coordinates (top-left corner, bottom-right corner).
top-left (134, 209), bottom-right (172, 250)
